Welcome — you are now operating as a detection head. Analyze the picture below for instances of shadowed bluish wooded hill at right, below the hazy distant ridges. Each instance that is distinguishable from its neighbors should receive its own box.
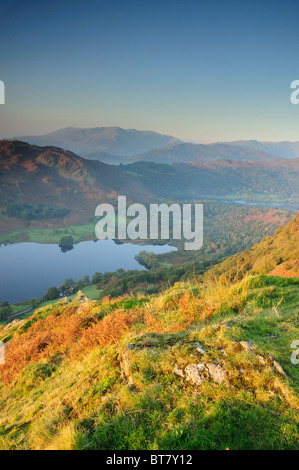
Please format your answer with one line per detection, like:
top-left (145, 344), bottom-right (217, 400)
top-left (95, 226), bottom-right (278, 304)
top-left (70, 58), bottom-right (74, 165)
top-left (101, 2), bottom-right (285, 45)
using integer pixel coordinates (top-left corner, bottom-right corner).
top-left (122, 159), bottom-right (299, 203)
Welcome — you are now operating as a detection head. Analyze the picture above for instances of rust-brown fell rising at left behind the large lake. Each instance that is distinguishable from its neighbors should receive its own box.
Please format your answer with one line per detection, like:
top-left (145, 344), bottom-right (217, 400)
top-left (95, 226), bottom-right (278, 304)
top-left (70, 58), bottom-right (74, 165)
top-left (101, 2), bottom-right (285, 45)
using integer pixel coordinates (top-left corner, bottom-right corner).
top-left (0, 140), bottom-right (154, 232)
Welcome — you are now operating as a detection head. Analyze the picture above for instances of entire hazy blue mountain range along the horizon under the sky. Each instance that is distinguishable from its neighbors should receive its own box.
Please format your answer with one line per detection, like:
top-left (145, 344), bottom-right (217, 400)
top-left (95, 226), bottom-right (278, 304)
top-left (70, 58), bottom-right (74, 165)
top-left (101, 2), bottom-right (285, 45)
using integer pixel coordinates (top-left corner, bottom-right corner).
top-left (12, 127), bottom-right (299, 165)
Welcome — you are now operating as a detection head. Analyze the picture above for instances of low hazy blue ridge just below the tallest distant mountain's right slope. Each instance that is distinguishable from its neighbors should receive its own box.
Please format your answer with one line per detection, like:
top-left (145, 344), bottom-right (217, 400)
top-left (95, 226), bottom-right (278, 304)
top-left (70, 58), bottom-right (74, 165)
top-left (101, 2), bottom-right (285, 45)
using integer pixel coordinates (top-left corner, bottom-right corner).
top-left (131, 143), bottom-right (277, 163)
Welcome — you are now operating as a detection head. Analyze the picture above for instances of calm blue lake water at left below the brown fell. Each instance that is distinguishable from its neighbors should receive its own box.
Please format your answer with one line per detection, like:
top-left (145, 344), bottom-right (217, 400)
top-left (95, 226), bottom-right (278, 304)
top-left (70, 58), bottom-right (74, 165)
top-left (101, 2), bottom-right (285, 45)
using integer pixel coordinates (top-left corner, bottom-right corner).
top-left (0, 240), bottom-right (176, 303)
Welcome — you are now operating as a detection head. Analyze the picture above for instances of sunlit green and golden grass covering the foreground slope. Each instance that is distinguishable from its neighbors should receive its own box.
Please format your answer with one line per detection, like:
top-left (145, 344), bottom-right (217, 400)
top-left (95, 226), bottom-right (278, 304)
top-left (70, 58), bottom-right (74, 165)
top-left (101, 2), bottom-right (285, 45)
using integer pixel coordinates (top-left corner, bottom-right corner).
top-left (0, 276), bottom-right (299, 450)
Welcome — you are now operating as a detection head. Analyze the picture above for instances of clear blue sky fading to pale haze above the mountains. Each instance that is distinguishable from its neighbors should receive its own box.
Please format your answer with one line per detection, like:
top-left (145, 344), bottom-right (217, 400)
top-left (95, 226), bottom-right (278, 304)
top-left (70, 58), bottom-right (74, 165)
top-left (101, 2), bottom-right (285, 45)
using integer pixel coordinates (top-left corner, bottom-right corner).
top-left (0, 0), bottom-right (299, 142)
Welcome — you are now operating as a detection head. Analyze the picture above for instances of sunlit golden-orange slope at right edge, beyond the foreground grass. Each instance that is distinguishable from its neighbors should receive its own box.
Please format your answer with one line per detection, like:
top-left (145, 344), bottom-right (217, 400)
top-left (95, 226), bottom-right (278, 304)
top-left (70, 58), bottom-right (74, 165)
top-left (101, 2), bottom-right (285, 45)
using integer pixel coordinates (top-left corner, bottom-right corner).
top-left (211, 212), bottom-right (299, 276)
